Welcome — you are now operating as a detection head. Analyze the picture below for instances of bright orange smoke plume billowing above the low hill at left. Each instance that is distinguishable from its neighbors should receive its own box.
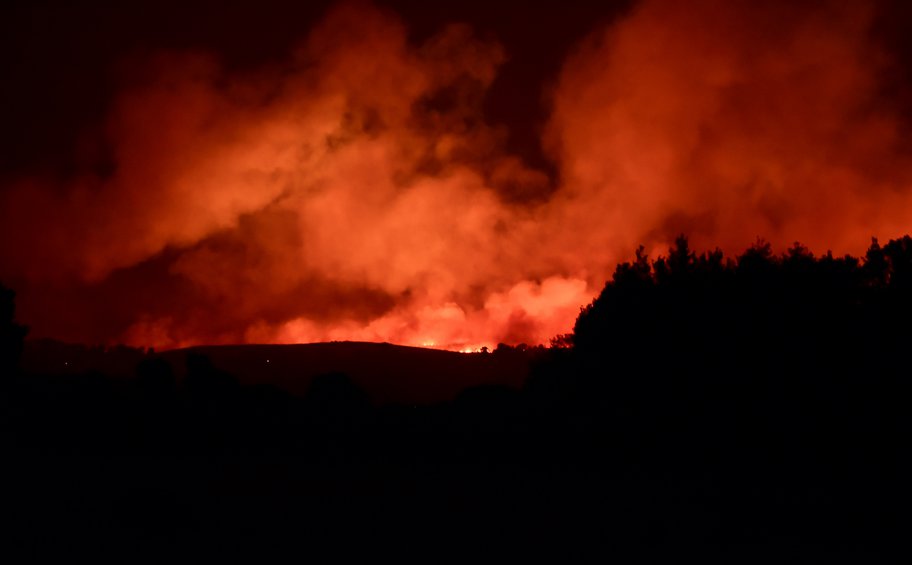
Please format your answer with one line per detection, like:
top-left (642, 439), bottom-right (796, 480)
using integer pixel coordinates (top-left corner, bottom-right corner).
top-left (2, 6), bottom-right (586, 347)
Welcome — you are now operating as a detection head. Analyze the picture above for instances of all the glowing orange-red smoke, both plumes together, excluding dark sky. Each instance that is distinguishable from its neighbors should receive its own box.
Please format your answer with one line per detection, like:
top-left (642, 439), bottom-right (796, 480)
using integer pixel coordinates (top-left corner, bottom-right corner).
top-left (0, 0), bottom-right (912, 349)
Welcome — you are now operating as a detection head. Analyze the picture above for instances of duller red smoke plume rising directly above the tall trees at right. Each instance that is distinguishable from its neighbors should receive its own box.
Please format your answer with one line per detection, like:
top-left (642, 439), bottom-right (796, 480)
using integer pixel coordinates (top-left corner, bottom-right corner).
top-left (548, 0), bottom-right (912, 264)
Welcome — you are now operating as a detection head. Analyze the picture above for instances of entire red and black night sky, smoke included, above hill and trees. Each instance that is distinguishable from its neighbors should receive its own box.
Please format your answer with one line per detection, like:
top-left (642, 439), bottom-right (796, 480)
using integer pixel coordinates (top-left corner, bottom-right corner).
top-left (0, 0), bottom-right (912, 349)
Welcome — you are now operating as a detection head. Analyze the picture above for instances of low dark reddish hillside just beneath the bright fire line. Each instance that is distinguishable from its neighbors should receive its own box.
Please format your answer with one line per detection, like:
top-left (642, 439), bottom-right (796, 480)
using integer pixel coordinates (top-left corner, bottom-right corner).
top-left (22, 341), bottom-right (531, 404)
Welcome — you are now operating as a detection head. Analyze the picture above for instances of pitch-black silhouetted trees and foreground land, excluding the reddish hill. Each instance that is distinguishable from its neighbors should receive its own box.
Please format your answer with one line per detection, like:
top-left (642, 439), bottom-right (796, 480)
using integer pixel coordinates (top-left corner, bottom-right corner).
top-left (0, 236), bottom-right (912, 563)
